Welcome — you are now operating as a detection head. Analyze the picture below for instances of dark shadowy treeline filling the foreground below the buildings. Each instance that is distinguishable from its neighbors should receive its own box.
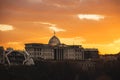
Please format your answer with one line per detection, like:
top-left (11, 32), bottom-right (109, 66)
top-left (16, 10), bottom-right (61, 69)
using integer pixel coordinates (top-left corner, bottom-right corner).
top-left (0, 61), bottom-right (120, 80)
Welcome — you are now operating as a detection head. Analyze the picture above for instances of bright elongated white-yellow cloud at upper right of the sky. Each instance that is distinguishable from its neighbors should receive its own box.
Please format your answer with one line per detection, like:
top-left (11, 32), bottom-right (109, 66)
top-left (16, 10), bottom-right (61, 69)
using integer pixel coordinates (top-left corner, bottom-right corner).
top-left (77, 14), bottom-right (105, 21)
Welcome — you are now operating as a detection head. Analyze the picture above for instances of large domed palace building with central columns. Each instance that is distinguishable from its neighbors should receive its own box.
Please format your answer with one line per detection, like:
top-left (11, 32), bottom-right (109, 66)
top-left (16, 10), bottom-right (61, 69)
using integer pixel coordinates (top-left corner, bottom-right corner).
top-left (25, 34), bottom-right (99, 60)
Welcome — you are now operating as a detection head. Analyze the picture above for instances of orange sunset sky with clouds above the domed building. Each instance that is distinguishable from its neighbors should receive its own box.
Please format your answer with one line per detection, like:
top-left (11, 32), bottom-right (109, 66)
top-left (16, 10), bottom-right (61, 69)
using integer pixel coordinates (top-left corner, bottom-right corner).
top-left (0, 0), bottom-right (120, 54)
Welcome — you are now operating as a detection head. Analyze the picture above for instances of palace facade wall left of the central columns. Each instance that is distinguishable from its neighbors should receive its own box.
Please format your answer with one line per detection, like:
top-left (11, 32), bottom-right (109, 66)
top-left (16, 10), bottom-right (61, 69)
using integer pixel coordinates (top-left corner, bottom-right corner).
top-left (25, 44), bottom-right (54, 59)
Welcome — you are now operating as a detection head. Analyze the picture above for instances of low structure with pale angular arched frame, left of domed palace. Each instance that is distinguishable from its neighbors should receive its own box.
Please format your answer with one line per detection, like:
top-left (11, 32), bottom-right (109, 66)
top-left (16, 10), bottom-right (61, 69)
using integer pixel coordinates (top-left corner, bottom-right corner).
top-left (4, 49), bottom-right (34, 65)
